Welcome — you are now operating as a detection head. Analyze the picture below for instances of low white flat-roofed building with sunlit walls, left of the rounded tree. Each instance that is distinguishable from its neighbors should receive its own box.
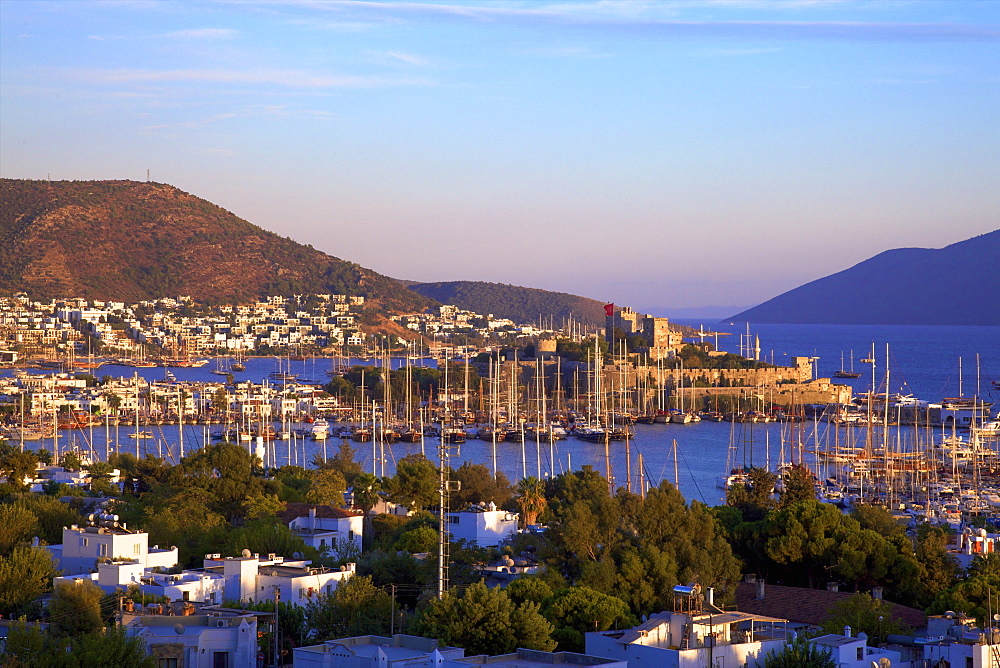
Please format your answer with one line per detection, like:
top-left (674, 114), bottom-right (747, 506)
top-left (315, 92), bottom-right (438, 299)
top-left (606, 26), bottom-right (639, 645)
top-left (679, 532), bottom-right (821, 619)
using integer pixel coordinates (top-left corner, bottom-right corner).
top-left (205, 550), bottom-right (355, 605)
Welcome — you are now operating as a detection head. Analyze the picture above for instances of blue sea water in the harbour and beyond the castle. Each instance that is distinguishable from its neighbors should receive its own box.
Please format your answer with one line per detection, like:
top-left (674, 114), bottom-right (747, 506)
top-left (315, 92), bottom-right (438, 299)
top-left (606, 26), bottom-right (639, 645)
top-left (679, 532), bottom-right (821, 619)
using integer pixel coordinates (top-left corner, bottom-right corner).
top-left (3, 320), bottom-right (1000, 505)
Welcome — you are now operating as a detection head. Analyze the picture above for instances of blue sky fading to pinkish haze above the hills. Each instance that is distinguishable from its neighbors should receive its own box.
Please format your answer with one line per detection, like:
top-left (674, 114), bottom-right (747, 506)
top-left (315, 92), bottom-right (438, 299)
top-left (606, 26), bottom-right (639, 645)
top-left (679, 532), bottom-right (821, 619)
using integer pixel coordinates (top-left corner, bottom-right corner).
top-left (0, 0), bottom-right (1000, 317)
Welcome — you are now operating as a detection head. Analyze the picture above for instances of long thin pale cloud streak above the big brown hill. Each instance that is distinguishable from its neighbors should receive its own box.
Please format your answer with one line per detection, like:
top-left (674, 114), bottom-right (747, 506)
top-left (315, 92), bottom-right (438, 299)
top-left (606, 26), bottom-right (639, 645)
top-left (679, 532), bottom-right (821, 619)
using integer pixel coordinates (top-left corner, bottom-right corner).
top-left (74, 69), bottom-right (433, 89)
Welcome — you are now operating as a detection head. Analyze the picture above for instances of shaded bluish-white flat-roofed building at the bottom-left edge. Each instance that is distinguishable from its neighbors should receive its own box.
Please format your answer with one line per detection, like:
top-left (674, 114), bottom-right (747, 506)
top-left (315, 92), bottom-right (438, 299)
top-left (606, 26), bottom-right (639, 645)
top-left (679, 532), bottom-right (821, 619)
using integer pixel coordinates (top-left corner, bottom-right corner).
top-left (122, 610), bottom-right (258, 668)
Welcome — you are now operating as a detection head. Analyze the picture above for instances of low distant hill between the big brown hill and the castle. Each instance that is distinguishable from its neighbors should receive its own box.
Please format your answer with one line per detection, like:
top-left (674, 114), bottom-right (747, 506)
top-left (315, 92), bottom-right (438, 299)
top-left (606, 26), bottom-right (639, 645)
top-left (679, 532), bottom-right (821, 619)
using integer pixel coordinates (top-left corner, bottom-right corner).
top-left (405, 281), bottom-right (604, 327)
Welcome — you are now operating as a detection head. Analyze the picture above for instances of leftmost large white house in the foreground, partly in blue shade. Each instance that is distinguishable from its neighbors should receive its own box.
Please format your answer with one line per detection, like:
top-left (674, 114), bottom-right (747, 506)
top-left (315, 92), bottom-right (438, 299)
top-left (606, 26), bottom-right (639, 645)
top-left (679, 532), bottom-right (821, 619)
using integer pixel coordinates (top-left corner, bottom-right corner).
top-left (47, 515), bottom-right (177, 575)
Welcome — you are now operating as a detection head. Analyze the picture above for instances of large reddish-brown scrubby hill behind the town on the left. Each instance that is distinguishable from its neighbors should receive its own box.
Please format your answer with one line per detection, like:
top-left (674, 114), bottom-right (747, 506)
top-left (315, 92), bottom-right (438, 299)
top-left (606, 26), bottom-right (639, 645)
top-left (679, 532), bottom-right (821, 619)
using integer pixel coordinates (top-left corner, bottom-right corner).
top-left (0, 179), bottom-right (433, 312)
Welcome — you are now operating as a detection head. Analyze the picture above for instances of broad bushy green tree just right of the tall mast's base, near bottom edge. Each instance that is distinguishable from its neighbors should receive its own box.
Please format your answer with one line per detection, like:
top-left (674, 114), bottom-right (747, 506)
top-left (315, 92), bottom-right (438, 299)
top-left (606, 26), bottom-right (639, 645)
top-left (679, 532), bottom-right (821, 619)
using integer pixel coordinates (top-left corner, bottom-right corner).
top-left (410, 582), bottom-right (556, 654)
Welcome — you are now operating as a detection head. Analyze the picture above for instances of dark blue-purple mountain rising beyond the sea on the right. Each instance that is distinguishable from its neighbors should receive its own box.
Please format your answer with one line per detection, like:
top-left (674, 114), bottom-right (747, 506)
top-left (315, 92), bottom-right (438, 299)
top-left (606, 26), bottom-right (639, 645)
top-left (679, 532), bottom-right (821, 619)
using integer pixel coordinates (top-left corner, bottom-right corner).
top-left (726, 230), bottom-right (1000, 325)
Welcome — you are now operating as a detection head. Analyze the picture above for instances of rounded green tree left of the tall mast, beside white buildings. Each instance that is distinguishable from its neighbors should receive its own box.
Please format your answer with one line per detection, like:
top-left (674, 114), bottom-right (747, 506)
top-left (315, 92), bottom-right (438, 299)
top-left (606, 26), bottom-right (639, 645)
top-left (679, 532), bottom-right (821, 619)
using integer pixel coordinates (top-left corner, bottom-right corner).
top-left (306, 575), bottom-right (392, 642)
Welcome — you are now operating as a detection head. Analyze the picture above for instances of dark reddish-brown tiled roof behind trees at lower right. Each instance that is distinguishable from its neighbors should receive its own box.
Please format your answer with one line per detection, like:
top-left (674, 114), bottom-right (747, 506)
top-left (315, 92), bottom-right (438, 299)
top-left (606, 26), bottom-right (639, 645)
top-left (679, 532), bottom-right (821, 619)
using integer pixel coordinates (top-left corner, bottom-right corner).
top-left (736, 582), bottom-right (927, 629)
